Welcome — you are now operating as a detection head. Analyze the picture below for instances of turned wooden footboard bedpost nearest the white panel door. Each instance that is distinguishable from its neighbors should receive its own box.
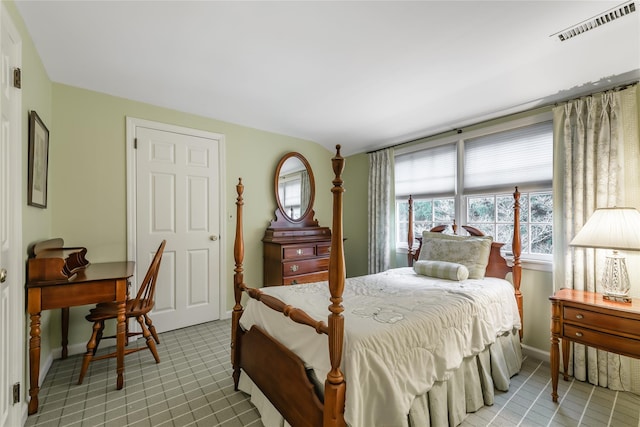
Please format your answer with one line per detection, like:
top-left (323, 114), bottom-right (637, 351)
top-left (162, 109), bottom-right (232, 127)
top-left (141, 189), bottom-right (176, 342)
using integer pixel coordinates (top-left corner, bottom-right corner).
top-left (231, 178), bottom-right (244, 390)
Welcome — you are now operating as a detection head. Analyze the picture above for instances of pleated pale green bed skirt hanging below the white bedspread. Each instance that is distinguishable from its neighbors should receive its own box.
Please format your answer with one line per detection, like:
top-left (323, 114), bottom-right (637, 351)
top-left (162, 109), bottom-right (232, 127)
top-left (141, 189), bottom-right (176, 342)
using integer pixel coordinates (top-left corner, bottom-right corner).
top-left (238, 331), bottom-right (522, 427)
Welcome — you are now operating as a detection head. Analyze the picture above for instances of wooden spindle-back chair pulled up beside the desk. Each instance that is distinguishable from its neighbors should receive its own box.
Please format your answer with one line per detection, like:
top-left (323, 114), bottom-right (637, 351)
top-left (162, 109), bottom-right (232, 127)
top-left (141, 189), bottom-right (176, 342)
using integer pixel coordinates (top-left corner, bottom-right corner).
top-left (78, 240), bottom-right (167, 384)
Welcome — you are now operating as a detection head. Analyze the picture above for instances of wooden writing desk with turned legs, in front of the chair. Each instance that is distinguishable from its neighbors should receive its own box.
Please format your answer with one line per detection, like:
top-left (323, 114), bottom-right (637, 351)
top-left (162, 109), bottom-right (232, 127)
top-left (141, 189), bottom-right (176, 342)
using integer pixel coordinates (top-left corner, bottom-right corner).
top-left (26, 261), bottom-right (134, 415)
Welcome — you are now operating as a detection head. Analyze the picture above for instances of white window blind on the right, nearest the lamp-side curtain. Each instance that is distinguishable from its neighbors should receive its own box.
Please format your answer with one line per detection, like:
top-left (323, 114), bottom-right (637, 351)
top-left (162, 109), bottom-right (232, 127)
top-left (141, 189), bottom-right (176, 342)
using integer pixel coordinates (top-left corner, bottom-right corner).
top-left (464, 122), bottom-right (553, 194)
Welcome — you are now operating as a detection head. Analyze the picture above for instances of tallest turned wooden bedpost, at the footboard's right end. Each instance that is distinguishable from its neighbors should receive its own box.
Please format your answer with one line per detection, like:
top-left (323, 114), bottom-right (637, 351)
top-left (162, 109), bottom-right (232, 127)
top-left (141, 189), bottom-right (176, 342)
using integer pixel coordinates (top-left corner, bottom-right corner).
top-left (323, 145), bottom-right (346, 427)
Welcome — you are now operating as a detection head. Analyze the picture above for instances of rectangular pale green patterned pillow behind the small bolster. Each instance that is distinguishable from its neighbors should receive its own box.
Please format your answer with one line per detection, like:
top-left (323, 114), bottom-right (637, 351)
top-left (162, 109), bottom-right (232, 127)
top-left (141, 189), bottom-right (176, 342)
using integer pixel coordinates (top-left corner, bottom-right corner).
top-left (418, 231), bottom-right (493, 279)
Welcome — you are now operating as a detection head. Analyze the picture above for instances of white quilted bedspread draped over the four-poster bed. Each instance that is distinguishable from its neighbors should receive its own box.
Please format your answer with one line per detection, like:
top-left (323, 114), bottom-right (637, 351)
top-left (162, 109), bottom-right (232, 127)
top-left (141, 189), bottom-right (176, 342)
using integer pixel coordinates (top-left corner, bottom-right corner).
top-left (240, 268), bottom-right (520, 427)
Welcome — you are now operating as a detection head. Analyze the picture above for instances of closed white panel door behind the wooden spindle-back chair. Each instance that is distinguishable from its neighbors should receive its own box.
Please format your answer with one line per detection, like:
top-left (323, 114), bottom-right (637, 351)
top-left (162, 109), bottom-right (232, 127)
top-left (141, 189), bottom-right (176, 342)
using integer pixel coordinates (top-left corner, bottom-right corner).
top-left (136, 126), bottom-right (220, 332)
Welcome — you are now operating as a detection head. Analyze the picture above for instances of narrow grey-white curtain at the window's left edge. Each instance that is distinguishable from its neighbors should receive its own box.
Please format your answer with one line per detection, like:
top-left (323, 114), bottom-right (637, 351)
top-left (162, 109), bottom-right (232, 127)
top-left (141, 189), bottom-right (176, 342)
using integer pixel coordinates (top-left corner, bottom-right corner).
top-left (368, 148), bottom-right (394, 273)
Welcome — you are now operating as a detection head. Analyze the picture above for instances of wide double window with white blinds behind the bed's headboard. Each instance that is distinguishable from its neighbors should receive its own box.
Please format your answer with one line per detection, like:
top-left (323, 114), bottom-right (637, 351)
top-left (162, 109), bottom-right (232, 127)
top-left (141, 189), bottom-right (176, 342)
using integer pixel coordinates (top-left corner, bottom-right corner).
top-left (395, 115), bottom-right (553, 261)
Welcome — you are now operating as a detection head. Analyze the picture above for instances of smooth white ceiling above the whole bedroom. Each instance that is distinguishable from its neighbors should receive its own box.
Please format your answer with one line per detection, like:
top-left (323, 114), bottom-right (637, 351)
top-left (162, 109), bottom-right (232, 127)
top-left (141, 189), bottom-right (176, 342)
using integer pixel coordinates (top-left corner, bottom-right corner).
top-left (15, 0), bottom-right (640, 155)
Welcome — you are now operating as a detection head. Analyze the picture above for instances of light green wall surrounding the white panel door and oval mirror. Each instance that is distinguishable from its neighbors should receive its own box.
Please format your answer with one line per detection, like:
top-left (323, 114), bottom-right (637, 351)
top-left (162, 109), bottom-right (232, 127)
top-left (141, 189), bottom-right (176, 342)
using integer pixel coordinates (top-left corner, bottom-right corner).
top-left (49, 83), bottom-right (333, 352)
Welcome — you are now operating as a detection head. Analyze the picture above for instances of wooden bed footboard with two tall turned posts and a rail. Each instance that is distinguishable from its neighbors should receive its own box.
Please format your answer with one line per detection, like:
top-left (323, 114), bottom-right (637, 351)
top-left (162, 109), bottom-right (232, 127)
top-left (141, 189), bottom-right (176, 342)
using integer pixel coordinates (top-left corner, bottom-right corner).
top-left (231, 145), bottom-right (346, 427)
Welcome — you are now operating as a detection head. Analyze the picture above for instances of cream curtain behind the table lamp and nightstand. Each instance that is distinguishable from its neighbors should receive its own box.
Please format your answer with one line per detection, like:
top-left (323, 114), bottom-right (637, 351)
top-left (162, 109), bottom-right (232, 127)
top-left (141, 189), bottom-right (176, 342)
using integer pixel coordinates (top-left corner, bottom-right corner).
top-left (553, 86), bottom-right (640, 392)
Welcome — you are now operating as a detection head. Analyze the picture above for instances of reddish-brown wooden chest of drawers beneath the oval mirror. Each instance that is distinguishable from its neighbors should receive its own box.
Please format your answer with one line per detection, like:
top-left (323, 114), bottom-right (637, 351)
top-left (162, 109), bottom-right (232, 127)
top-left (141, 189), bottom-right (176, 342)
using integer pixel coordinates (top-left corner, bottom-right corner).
top-left (262, 227), bottom-right (331, 286)
